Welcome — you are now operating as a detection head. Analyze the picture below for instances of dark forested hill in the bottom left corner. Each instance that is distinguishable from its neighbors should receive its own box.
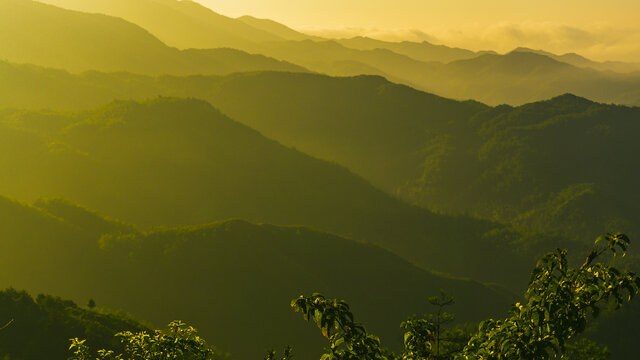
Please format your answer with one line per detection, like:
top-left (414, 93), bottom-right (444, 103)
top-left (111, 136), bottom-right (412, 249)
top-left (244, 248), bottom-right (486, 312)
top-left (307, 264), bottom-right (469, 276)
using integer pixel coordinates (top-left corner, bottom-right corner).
top-left (0, 288), bottom-right (147, 360)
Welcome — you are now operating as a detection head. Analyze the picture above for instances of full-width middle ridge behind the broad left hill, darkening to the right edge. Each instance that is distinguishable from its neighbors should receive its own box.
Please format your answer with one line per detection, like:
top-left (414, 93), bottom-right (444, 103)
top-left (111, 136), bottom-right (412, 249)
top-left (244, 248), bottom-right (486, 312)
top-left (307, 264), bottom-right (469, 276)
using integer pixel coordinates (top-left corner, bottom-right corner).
top-left (0, 63), bottom-right (640, 250)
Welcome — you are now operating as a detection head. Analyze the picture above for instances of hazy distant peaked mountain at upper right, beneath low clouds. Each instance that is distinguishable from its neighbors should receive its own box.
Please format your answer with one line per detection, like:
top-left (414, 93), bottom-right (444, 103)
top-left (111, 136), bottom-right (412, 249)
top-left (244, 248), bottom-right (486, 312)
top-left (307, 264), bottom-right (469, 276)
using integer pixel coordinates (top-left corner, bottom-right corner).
top-left (415, 52), bottom-right (640, 105)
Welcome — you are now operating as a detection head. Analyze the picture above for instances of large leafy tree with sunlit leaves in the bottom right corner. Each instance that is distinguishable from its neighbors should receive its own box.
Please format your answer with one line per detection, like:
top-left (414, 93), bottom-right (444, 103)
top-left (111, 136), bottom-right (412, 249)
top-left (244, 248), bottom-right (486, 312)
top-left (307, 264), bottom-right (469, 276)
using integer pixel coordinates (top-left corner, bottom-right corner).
top-left (461, 234), bottom-right (640, 360)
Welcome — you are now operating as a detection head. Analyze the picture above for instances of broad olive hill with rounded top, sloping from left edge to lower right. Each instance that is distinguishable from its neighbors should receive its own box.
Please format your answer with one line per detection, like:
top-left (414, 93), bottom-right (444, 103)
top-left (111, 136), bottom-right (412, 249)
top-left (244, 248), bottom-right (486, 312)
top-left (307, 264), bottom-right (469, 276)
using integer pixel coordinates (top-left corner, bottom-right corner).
top-left (0, 99), bottom-right (530, 283)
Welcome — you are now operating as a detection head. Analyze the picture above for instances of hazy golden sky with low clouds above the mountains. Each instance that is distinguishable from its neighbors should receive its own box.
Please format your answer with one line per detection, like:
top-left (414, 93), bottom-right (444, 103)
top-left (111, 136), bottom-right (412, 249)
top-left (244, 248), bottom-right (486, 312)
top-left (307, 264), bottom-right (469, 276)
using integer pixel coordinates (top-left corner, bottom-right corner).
top-left (198, 0), bottom-right (640, 62)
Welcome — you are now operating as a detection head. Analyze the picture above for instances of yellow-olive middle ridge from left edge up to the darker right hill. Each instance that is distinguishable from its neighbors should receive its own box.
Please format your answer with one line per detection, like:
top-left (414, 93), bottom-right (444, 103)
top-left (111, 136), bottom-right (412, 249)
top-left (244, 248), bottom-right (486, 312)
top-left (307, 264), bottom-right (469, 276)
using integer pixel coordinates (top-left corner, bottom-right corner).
top-left (0, 63), bottom-right (480, 192)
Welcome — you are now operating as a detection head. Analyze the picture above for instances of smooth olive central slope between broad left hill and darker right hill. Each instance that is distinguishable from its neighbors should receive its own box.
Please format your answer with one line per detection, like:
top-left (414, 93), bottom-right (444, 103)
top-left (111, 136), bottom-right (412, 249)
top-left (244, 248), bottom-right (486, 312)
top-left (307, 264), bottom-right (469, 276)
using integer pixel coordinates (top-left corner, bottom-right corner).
top-left (178, 73), bottom-right (487, 192)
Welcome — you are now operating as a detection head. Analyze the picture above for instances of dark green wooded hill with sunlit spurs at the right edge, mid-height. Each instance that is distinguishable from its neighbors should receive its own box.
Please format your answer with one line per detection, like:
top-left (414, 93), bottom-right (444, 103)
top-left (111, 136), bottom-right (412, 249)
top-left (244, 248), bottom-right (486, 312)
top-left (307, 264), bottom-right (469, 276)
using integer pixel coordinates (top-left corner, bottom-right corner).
top-left (400, 95), bottom-right (640, 242)
